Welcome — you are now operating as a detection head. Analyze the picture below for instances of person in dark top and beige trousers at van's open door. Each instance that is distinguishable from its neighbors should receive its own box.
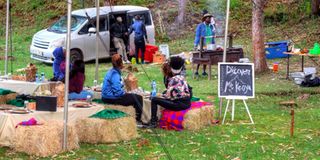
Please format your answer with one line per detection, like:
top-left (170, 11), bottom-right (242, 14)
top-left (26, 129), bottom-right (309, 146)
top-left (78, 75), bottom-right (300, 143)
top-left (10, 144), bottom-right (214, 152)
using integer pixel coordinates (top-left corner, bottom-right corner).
top-left (110, 17), bottom-right (130, 63)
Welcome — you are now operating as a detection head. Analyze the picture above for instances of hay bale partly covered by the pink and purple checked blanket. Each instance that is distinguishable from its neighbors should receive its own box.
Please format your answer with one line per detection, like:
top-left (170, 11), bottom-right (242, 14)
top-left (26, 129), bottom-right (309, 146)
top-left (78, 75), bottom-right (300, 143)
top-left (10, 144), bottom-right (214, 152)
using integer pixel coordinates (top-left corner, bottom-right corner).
top-left (182, 105), bottom-right (214, 130)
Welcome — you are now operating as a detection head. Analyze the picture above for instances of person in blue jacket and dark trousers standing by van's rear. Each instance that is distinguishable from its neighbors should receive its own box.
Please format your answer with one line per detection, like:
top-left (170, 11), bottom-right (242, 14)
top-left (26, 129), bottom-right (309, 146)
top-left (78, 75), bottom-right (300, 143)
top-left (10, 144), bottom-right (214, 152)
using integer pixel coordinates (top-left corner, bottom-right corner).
top-left (130, 15), bottom-right (149, 64)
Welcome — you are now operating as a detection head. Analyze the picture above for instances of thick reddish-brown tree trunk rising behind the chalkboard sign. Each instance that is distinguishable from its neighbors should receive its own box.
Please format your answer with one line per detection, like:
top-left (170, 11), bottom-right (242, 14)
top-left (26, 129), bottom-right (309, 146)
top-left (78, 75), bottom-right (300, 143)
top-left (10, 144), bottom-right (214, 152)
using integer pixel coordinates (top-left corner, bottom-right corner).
top-left (252, 0), bottom-right (268, 73)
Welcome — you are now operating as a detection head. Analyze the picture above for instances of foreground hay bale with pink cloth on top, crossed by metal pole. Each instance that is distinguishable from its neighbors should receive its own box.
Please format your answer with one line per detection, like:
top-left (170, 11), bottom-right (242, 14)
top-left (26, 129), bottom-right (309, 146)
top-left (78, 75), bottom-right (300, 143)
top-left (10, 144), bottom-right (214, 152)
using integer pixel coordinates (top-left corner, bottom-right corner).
top-left (13, 121), bottom-right (79, 157)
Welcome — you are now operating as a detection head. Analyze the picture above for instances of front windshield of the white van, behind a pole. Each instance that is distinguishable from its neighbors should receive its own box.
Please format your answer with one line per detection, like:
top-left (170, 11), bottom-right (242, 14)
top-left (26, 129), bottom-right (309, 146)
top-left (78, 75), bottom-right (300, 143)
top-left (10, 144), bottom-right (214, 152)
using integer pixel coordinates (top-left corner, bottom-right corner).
top-left (48, 15), bottom-right (87, 33)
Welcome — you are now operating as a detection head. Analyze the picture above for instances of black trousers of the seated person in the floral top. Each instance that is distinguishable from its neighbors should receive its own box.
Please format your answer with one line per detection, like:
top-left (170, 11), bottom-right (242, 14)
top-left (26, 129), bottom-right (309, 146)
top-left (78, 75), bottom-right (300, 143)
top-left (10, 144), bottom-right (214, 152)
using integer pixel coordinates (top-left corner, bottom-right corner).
top-left (151, 97), bottom-right (191, 122)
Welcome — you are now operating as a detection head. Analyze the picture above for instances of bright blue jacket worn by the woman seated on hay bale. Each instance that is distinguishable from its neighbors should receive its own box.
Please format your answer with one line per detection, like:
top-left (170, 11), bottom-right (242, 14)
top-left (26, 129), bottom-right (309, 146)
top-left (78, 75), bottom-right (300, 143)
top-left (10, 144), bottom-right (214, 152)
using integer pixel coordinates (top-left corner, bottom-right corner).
top-left (102, 67), bottom-right (125, 99)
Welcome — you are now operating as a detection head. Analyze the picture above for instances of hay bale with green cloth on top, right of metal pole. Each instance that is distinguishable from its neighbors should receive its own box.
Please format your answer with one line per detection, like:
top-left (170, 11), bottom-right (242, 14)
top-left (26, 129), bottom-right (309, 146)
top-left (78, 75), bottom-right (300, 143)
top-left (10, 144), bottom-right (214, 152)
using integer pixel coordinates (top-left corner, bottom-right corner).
top-left (75, 117), bottom-right (138, 144)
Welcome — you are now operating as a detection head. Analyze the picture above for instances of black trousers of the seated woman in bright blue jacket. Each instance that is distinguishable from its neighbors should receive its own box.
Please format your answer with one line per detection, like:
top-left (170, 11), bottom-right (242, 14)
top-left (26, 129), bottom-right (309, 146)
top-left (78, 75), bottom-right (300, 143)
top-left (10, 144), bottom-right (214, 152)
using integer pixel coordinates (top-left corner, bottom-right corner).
top-left (102, 93), bottom-right (142, 121)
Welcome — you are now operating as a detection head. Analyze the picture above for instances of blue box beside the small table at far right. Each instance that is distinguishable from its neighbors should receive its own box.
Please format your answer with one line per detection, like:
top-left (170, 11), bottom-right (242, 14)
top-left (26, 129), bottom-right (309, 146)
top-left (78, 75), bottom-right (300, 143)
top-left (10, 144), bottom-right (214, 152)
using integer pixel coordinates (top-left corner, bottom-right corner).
top-left (265, 41), bottom-right (290, 59)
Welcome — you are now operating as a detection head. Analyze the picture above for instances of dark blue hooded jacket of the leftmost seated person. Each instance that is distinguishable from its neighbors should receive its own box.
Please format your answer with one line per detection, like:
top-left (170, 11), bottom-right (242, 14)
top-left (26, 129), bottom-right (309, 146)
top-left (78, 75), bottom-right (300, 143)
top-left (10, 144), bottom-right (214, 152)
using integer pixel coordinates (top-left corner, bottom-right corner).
top-left (52, 47), bottom-right (65, 80)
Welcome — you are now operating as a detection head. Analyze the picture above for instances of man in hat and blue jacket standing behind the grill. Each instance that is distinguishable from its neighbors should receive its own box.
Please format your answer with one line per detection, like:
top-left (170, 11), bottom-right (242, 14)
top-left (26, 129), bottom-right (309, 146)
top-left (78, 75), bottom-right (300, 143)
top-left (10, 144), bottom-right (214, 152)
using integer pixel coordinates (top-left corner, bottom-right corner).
top-left (194, 13), bottom-right (215, 76)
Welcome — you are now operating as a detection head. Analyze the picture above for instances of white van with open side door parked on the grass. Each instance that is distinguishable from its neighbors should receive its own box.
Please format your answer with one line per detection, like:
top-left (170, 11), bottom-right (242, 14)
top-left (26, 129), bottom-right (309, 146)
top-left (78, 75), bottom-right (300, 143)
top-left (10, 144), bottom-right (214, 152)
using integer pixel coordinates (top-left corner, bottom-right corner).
top-left (30, 6), bottom-right (155, 63)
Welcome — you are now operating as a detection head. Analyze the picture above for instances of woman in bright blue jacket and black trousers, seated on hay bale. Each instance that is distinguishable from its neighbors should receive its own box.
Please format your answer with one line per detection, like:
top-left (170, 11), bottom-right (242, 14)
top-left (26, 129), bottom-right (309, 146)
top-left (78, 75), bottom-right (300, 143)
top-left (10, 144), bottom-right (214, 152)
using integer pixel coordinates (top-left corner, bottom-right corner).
top-left (101, 54), bottom-right (142, 126)
